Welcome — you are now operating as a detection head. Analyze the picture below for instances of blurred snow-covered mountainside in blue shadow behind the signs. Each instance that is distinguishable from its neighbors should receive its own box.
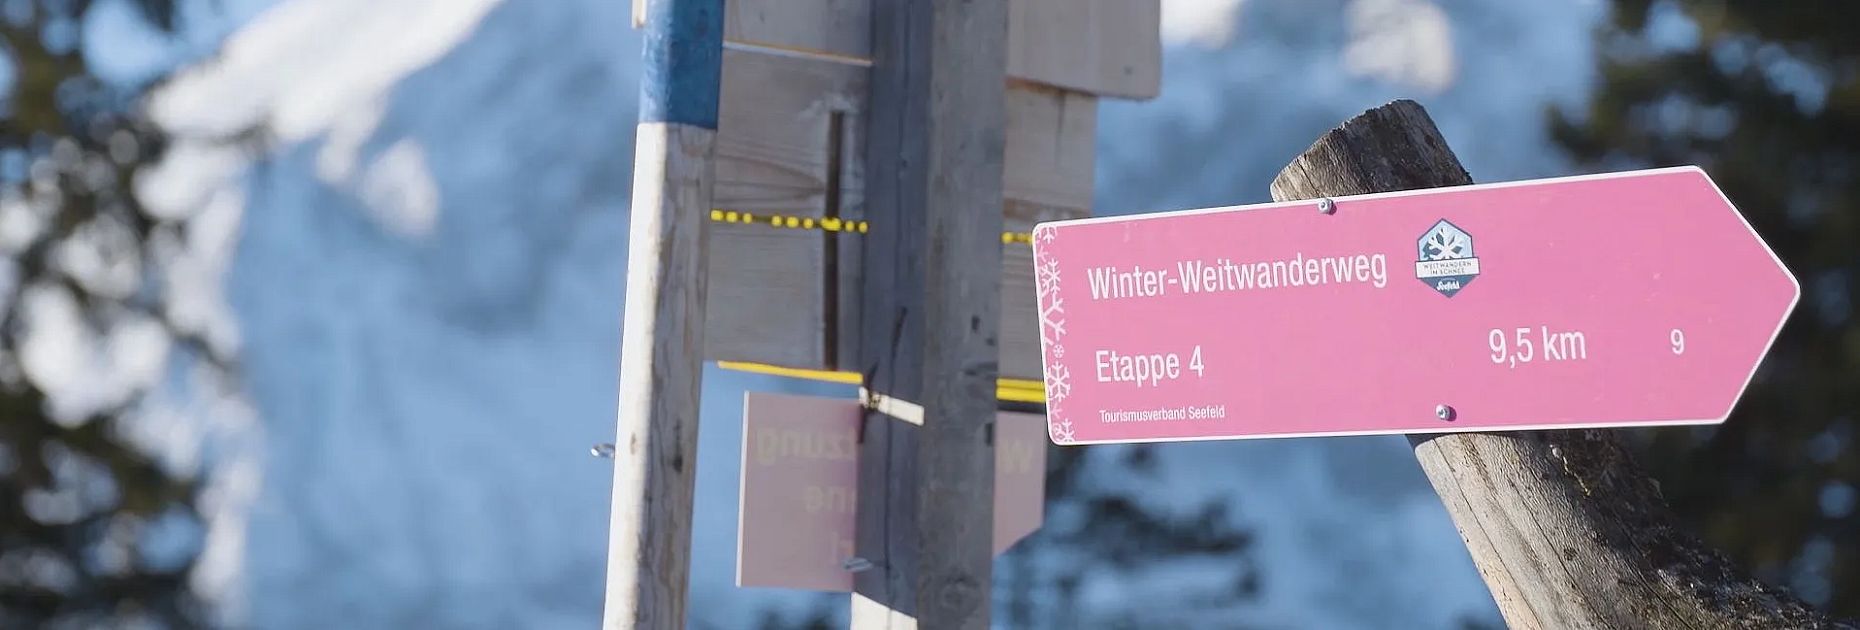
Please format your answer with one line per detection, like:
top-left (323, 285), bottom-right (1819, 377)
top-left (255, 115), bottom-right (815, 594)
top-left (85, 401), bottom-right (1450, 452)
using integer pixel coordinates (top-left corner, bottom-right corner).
top-left (131, 0), bottom-right (1600, 628)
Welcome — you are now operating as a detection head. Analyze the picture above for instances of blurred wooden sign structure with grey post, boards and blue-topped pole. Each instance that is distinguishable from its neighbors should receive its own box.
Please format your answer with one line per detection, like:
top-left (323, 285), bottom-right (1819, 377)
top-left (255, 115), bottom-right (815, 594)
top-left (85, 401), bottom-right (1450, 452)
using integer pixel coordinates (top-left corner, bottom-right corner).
top-left (605, 0), bottom-right (1161, 628)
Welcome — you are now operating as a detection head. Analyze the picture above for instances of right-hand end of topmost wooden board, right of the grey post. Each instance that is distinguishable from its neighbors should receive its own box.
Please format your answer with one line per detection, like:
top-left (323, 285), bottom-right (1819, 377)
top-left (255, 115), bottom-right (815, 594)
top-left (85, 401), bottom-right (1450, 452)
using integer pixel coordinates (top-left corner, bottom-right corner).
top-left (1008, 0), bottom-right (1163, 98)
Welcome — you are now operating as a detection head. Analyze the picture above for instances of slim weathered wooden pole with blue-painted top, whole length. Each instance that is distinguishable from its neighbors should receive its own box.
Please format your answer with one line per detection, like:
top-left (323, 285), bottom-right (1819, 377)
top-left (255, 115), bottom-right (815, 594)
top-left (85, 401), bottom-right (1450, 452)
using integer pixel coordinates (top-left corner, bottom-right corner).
top-left (603, 0), bottom-right (724, 630)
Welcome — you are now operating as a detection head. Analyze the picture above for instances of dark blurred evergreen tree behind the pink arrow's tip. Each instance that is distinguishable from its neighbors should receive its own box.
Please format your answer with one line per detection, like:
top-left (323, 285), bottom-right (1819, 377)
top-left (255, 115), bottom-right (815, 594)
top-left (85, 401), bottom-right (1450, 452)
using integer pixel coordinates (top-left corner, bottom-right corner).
top-left (1551, 0), bottom-right (1860, 615)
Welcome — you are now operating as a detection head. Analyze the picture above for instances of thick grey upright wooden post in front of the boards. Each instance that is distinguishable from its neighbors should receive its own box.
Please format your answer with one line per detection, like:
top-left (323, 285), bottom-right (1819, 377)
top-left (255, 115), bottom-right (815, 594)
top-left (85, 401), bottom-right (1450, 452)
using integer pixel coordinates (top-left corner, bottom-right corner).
top-left (852, 0), bottom-right (1008, 630)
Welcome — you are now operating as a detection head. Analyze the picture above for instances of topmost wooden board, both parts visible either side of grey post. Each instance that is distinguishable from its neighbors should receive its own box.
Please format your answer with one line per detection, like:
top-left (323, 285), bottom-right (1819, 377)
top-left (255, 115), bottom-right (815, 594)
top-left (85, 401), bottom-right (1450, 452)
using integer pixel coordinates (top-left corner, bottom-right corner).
top-left (634, 0), bottom-right (1163, 98)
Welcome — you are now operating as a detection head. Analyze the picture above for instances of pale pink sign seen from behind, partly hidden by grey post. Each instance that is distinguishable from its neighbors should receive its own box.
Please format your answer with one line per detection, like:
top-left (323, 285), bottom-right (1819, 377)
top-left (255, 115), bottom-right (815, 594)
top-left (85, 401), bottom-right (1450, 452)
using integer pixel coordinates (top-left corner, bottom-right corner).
top-left (737, 392), bottom-right (1045, 593)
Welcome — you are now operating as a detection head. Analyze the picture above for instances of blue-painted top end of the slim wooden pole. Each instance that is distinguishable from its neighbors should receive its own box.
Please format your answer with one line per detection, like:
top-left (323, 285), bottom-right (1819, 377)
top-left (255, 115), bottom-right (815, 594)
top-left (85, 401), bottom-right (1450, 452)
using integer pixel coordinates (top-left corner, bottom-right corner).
top-left (640, 0), bottom-right (724, 130)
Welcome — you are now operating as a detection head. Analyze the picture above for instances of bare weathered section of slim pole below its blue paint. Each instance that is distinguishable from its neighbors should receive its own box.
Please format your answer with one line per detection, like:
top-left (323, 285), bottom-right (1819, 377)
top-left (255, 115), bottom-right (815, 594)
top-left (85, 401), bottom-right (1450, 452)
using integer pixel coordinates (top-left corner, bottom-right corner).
top-left (603, 123), bottom-right (714, 630)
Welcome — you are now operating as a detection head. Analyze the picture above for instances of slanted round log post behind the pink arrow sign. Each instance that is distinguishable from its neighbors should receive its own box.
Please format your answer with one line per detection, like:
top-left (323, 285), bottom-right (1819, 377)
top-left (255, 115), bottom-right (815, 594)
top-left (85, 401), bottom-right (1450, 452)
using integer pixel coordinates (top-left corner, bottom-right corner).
top-left (1272, 100), bottom-right (1853, 630)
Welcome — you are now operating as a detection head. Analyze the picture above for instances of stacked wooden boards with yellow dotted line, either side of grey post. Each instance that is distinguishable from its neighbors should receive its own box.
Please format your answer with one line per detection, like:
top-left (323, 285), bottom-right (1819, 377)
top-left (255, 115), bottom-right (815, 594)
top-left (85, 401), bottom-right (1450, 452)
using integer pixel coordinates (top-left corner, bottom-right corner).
top-left (684, 0), bottom-right (1161, 381)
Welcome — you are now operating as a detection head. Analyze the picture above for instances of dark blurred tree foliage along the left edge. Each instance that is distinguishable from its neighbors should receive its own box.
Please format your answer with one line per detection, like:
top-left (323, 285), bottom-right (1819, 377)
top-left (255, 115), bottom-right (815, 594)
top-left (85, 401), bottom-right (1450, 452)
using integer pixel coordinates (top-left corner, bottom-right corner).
top-left (0, 0), bottom-right (231, 628)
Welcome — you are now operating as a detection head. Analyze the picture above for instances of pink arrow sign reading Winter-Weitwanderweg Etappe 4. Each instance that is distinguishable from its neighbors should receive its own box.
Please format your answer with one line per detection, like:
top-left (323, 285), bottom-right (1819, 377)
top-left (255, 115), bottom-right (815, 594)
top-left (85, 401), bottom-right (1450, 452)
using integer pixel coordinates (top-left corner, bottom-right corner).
top-left (1034, 167), bottom-right (1800, 444)
